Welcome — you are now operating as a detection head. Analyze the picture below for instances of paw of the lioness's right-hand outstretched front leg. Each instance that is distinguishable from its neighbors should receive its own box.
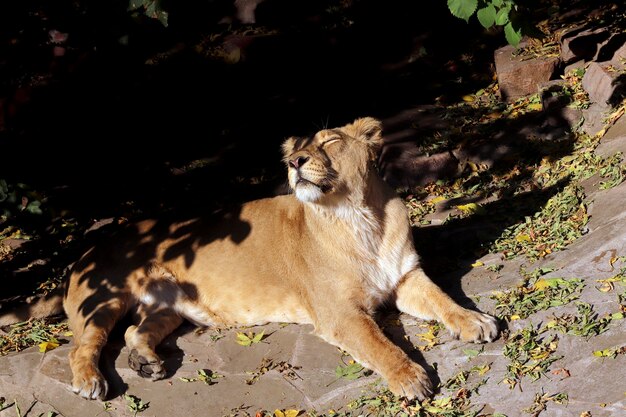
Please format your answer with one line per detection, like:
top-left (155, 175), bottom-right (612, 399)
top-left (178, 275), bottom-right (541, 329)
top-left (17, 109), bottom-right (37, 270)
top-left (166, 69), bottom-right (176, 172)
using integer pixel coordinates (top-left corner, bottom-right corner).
top-left (444, 308), bottom-right (498, 343)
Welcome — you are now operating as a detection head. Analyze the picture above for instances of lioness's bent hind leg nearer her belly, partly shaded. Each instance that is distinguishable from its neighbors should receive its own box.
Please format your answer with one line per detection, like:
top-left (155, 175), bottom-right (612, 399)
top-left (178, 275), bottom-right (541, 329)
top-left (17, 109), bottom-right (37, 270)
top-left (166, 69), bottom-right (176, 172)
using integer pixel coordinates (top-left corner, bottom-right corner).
top-left (124, 304), bottom-right (183, 381)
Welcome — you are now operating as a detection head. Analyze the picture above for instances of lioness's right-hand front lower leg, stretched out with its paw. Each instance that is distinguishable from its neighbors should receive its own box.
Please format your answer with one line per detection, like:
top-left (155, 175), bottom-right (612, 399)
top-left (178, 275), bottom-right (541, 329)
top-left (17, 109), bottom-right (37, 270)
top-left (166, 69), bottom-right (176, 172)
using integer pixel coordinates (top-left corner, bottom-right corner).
top-left (396, 269), bottom-right (498, 343)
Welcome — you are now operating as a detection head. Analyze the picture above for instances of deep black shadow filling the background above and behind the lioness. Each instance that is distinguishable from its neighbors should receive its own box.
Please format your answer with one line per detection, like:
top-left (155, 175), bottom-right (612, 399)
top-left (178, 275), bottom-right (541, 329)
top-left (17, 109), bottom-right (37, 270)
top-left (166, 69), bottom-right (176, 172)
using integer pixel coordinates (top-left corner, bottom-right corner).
top-left (0, 0), bottom-right (504, 214)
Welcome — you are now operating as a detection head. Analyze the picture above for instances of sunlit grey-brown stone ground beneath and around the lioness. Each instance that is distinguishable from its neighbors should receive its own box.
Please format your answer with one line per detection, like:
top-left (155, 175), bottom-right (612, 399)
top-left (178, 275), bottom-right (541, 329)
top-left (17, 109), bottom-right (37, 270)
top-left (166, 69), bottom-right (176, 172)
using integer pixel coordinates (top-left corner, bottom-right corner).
top-left (0, 118), bottom-right (626, 417)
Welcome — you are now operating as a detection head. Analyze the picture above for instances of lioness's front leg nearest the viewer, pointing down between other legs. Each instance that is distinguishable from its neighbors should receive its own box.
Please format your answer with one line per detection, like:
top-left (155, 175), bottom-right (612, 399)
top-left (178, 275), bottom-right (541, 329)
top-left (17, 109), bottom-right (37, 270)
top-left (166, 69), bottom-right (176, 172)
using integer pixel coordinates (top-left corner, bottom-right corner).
top-left (316, 309), bottom-right (433, 400)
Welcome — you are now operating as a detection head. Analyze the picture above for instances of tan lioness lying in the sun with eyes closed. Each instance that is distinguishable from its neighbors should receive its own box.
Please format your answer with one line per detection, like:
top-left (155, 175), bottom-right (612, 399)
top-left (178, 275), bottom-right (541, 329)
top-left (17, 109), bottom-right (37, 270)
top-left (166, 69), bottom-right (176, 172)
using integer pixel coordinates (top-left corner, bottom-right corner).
top-left (45, 117), bottom-right (498, 400)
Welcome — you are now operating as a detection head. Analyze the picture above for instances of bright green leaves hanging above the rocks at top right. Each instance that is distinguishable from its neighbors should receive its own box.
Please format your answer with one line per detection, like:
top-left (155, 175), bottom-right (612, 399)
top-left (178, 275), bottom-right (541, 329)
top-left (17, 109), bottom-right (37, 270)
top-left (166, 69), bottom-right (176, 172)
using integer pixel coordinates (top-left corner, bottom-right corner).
top-left (448, 0), bottom-right (523, 46)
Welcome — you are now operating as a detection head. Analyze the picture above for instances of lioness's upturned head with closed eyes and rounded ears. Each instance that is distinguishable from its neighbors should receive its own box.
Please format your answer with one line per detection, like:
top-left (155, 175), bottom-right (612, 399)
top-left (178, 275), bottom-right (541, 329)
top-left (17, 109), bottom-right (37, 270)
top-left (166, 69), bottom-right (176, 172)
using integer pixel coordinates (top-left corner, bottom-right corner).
top-left (283, 117), bottom-right (382, 203)
